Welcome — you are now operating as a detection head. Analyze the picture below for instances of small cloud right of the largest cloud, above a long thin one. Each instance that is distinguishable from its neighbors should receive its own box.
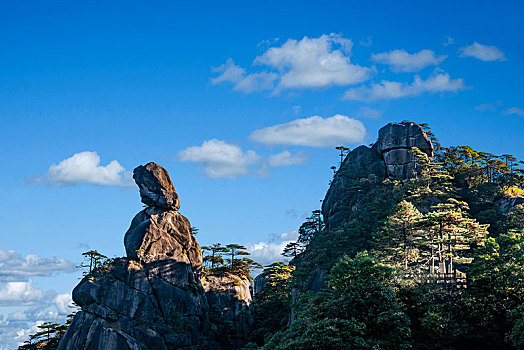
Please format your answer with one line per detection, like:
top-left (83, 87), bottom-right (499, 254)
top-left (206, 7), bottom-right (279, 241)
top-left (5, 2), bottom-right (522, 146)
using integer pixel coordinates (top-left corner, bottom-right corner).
top-left (371, 50), bottom-right (447, 72)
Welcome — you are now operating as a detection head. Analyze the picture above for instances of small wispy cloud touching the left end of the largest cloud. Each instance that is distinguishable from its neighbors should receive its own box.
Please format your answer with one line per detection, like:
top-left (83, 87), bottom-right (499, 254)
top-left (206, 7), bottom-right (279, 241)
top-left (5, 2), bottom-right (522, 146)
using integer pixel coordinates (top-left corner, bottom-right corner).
top-left (211, 58), bottom-right (278, 93)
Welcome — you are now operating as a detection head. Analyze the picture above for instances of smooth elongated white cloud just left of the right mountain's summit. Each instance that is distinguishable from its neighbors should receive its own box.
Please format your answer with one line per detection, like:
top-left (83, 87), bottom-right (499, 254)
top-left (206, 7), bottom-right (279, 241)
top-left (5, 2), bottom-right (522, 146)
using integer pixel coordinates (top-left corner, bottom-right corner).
top-left (249, 114), bottom-right (366, 147)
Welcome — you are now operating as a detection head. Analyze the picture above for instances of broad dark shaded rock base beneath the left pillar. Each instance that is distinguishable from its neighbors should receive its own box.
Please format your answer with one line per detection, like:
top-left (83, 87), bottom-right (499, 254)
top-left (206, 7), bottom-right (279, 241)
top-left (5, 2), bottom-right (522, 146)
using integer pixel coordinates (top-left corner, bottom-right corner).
top-left (58, 259), bottom-right (208, 350)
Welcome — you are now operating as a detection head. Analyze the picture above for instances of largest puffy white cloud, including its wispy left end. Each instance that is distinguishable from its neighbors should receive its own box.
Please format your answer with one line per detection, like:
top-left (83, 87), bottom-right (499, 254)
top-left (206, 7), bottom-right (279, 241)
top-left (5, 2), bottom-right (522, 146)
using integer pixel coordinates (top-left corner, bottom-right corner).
top-left (211, 34), bottom-right (371, 92)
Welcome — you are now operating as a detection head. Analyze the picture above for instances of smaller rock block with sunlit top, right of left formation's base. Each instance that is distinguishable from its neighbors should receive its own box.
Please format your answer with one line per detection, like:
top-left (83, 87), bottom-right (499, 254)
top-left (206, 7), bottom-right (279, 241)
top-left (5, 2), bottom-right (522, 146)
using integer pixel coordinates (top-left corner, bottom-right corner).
top-left (202, 272), bottom-right (254, 349)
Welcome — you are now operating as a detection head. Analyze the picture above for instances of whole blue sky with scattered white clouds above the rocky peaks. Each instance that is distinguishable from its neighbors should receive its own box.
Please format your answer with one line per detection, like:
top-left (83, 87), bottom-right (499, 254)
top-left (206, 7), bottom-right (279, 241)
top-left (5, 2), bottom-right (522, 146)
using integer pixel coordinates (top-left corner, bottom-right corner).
top-left (0, 1), bottom-right (524, 349)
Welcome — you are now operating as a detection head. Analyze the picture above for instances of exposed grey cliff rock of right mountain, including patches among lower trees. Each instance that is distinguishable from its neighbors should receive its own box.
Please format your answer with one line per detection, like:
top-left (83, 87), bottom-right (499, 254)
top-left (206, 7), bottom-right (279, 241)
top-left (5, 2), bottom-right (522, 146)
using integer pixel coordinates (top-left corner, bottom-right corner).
top-left (291, 122), bottom-right (433, 321)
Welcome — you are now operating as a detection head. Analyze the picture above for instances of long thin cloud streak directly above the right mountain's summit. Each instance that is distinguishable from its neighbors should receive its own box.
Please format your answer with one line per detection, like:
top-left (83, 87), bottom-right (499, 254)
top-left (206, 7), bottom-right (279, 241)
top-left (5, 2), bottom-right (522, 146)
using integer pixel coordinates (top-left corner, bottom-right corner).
top-left (343, 73), bottom-right (467, 101)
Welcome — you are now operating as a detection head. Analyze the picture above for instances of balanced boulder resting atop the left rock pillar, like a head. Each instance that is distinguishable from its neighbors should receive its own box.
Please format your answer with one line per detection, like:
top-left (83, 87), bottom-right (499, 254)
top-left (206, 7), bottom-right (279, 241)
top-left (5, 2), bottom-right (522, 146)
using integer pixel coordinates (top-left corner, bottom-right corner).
top-left (133, 162), bottom-right (180, 210)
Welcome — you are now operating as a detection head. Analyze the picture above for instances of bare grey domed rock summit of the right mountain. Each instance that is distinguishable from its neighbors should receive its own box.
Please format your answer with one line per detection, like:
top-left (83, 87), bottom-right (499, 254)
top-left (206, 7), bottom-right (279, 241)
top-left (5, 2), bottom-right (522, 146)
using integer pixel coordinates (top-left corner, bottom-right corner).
top-left (322, 122), bottom-right (433, 228)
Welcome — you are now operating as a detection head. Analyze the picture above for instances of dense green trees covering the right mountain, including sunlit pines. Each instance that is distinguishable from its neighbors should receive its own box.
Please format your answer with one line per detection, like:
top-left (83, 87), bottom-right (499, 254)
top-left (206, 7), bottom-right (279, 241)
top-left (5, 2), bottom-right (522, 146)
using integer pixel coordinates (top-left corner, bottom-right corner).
top-left (250, 133), bottom-right (524, 349)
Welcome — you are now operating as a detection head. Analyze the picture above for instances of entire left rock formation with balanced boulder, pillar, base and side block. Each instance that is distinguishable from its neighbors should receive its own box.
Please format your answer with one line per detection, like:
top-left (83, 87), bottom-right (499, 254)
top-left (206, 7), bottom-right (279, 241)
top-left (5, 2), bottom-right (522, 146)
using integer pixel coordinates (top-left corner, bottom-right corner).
top-left (58, 163), bottom-right (251, 350)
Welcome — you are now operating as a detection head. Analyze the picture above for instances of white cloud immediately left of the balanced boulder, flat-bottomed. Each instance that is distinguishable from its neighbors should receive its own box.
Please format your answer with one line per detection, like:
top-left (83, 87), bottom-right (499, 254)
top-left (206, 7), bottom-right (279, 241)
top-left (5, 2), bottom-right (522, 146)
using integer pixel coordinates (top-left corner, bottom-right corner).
top-left (27, 151), bottom-right (133, 187)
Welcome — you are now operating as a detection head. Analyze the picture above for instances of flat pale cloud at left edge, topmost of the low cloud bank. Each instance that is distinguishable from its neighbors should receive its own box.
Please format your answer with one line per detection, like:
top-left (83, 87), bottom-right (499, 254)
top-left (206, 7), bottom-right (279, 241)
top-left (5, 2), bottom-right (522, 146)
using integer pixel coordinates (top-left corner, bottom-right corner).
top-left (0, 249), bottom-right (75, 281)
